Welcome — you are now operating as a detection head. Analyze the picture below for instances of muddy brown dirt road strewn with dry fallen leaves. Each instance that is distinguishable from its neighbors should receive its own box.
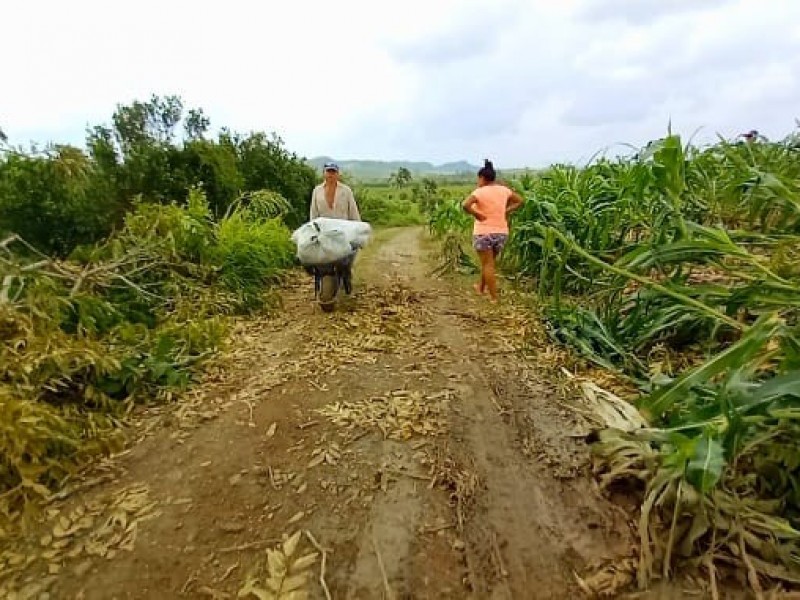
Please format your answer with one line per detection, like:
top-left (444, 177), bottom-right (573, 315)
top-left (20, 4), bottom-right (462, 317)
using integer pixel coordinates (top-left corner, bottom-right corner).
top-left (0, 229), bottom-right (688, 599)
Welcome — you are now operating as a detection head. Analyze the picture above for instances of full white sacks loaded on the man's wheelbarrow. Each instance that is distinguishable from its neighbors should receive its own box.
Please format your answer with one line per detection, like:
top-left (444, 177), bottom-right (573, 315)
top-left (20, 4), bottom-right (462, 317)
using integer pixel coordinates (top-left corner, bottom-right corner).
top-left (292, 217), bottom-right (372, 266)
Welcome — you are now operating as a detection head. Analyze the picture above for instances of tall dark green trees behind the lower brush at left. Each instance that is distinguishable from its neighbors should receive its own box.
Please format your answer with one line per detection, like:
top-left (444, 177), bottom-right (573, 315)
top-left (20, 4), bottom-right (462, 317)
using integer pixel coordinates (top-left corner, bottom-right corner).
top-left (0, 96), bottom-right (316, 257)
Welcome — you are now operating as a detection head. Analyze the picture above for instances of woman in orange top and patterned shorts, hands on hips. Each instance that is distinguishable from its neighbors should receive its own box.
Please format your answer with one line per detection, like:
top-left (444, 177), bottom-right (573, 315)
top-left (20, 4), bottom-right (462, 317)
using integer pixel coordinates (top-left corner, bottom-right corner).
top-left (464, 160), bottom-right (522, 302)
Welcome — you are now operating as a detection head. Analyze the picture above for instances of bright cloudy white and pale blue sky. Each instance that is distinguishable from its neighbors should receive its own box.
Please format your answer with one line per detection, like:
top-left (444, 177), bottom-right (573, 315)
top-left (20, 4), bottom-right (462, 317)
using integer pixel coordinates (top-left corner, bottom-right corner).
top-left (0, 0), bottom-right (800, 167)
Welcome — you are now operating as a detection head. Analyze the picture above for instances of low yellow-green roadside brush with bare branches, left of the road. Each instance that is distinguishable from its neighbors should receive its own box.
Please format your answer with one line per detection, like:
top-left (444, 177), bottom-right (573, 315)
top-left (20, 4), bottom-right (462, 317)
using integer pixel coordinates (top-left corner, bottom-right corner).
top-left (0, 189), bottom-right (294, 527)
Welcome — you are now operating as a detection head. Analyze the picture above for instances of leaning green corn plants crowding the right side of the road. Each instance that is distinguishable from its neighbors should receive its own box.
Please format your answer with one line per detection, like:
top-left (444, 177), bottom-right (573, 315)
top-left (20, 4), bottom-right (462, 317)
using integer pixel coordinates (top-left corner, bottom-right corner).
top-left (429, 126), bottom-right (800, 592)
